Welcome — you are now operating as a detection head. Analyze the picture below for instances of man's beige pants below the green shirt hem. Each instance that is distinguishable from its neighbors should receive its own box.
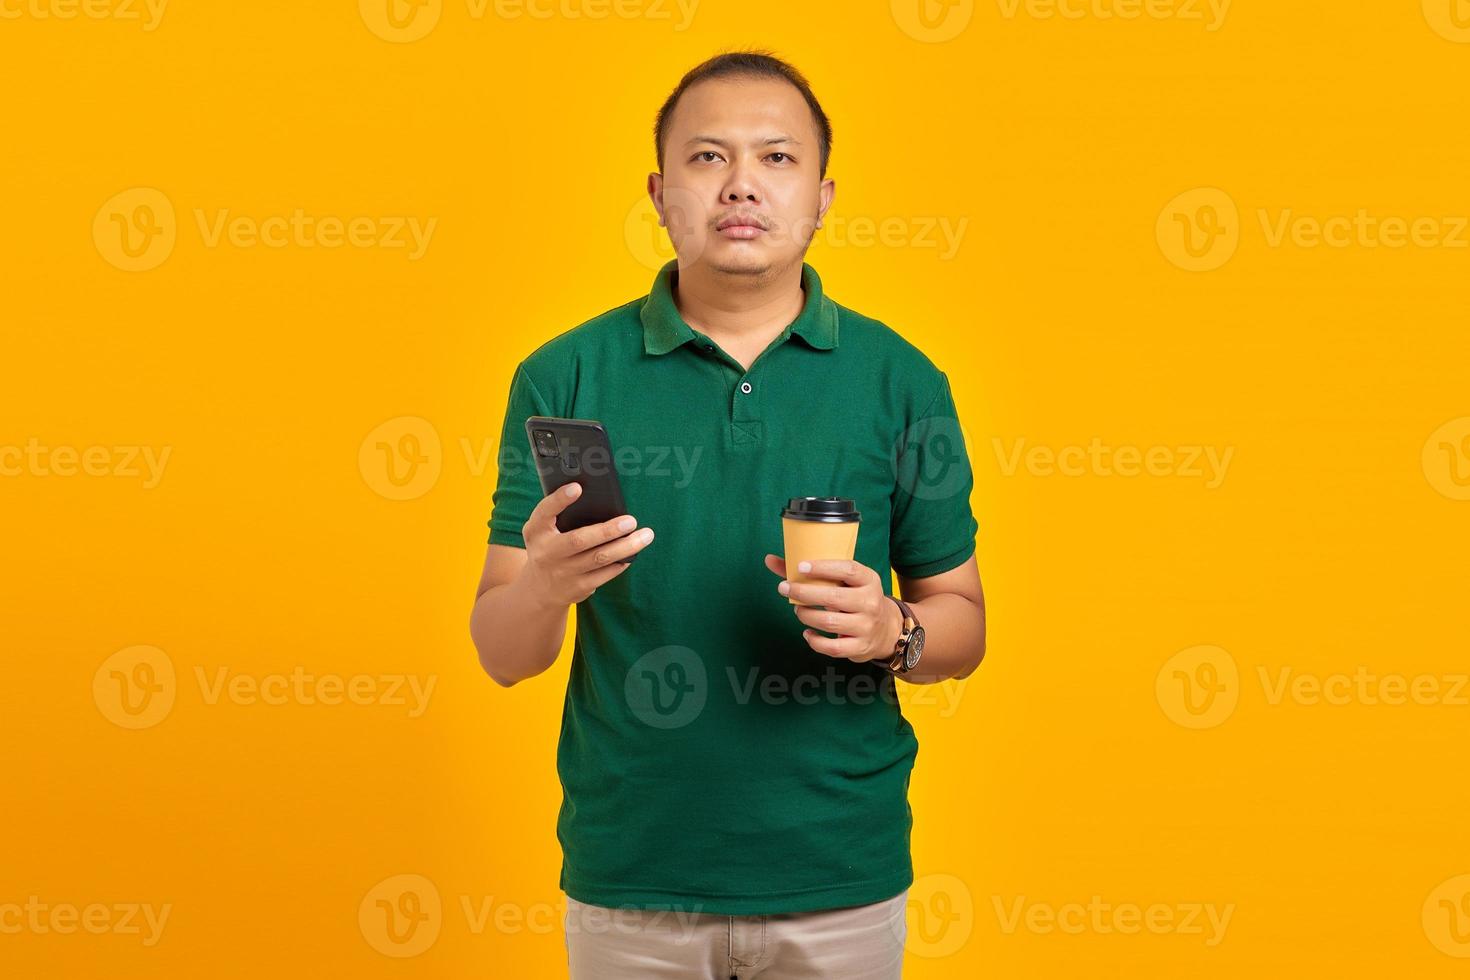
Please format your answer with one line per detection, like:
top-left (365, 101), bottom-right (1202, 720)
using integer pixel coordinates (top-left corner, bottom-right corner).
top-left (563, 889), bottom-right (908, 980)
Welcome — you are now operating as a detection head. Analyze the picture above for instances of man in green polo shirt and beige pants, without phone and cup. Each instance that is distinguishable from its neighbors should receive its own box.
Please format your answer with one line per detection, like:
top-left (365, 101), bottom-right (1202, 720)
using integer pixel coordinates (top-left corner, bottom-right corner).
top-left (470, 53), bottom-right (985, 980)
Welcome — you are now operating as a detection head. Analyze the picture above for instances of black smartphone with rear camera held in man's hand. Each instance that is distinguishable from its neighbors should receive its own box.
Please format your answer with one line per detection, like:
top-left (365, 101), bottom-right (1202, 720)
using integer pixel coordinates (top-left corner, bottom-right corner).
top-left (526, 416), bottom-right (638, 564)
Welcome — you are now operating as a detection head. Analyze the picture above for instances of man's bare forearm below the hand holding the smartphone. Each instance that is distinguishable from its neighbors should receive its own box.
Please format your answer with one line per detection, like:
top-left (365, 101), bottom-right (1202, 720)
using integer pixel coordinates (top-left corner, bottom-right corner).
top-left (469, 572), bottom-right (570, 688)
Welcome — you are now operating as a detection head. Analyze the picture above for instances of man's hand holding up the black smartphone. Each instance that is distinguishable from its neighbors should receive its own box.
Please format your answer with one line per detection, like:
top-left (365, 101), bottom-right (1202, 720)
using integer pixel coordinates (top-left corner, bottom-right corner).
top-left (522, 483), bottom-right (653, 607)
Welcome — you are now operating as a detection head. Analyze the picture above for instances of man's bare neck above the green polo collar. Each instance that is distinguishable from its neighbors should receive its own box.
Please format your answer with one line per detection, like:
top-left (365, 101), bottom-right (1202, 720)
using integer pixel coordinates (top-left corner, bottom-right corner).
top-left (673, 262), bottom-right (807, 347)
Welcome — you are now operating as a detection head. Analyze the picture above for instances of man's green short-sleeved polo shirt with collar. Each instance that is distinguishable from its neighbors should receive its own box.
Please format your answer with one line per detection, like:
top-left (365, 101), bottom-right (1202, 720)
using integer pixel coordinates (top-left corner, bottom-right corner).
top-left (490, 262), bottom-right (976, 915)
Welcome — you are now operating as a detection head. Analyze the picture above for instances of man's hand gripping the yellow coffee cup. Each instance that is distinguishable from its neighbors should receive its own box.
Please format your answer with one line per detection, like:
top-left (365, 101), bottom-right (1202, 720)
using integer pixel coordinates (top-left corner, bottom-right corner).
top-left (766, 554), bottom-right (903, 663)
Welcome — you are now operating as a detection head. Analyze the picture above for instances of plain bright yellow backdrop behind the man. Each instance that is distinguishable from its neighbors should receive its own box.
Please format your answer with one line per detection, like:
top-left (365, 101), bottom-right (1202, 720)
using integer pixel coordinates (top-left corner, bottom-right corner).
top-left (0, 0), bottom-right (1470, 977)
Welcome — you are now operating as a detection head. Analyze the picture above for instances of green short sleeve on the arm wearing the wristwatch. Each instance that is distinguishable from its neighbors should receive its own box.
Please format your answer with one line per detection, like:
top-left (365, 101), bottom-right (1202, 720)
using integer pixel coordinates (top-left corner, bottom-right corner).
top-left (889, 372), bottom-right (979, 579)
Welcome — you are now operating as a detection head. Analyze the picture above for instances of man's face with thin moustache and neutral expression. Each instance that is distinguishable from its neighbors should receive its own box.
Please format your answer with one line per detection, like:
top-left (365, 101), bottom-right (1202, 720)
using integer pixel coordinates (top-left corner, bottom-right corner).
top-left (648, 78), bottom-right (835, 279)
